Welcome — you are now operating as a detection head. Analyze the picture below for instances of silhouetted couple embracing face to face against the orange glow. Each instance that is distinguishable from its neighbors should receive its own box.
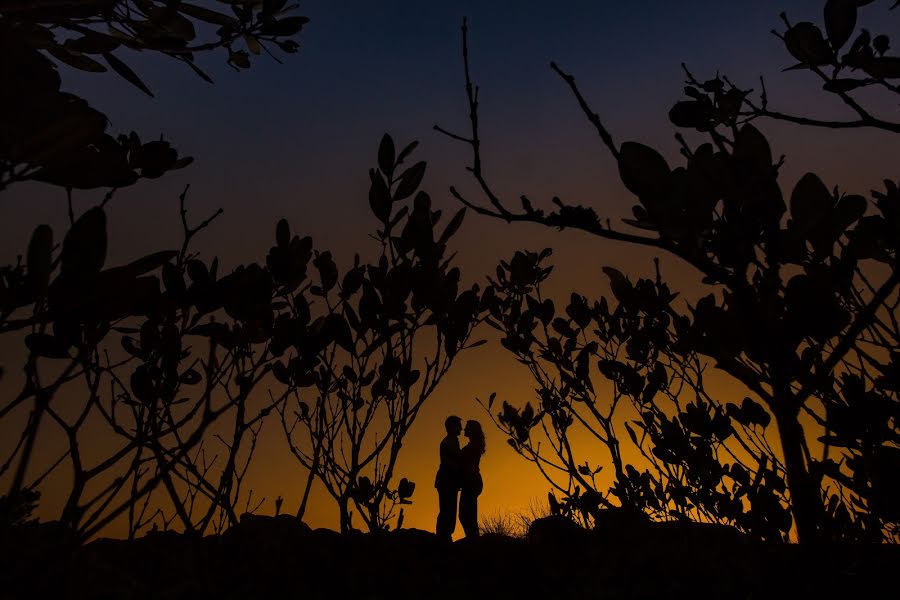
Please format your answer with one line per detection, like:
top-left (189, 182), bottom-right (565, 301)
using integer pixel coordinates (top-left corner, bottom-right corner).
top-left (434, 416), bottom-right (486, 541)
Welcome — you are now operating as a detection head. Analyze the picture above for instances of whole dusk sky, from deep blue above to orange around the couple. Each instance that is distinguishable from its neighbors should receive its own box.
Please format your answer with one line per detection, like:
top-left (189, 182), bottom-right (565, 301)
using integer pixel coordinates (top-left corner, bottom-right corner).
top-left (0, 0), bottom-right (900, 540)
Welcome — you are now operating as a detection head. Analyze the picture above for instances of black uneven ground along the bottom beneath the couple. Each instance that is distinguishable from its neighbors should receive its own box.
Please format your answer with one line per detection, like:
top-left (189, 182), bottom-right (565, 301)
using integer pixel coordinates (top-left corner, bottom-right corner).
top-left (0, 516), bottom-right (900, 600)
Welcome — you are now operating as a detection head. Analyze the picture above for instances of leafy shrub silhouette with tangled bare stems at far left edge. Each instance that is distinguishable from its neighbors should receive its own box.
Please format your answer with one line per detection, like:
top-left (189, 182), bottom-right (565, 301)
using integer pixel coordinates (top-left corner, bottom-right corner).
top-left (0, 185), bottom-right (284, 538)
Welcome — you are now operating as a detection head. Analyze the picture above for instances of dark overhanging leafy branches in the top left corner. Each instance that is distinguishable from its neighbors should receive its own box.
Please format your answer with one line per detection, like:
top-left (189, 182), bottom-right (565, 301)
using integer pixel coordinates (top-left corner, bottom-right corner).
top-left (0, 0), bottom-right (308, 192)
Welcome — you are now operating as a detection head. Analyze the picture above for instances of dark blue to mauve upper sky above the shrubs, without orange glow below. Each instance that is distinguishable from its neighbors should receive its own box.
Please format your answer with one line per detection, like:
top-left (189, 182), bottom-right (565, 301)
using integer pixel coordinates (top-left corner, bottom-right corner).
top-left (0, 0), bottom-right (896, 278)
